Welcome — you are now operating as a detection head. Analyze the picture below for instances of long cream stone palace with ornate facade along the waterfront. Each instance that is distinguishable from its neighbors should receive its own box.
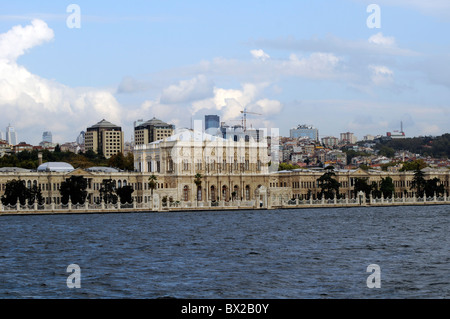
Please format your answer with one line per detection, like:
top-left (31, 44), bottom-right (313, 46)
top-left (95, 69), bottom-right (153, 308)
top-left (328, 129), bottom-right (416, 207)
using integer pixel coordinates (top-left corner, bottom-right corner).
top-left (0, 129), bottom-right (450, 207)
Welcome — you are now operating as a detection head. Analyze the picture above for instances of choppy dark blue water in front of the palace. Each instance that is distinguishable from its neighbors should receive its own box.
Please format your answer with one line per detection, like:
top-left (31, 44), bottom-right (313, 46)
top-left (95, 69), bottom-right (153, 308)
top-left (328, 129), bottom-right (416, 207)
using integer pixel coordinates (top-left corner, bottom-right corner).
top-left (0, 206), bottom-right (450, 299)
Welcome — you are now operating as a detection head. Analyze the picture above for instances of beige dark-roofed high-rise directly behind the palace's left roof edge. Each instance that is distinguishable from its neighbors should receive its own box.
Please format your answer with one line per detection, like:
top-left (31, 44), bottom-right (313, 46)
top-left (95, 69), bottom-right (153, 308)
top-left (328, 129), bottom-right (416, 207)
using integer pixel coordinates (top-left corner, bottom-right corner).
top-left (134, 118), bottom-right (175, 145)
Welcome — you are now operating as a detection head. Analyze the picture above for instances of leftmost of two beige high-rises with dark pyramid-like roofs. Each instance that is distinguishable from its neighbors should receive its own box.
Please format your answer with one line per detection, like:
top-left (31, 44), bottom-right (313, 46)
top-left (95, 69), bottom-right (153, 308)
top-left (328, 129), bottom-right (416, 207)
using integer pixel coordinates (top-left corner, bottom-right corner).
top-left (85, 120), bottom-right (123, 158)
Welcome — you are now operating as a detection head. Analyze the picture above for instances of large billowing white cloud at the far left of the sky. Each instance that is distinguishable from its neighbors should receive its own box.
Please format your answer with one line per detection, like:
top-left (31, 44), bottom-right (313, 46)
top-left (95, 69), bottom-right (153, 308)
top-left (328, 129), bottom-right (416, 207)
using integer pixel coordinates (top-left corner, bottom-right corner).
top-left (0, 20), bottom-right (121, 144)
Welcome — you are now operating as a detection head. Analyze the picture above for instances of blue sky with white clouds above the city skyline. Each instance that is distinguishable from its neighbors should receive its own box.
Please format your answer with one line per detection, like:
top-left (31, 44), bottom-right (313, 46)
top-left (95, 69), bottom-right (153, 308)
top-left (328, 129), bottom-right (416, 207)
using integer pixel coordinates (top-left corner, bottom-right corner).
top-left (0, 0), bottom-right (450, 145)
